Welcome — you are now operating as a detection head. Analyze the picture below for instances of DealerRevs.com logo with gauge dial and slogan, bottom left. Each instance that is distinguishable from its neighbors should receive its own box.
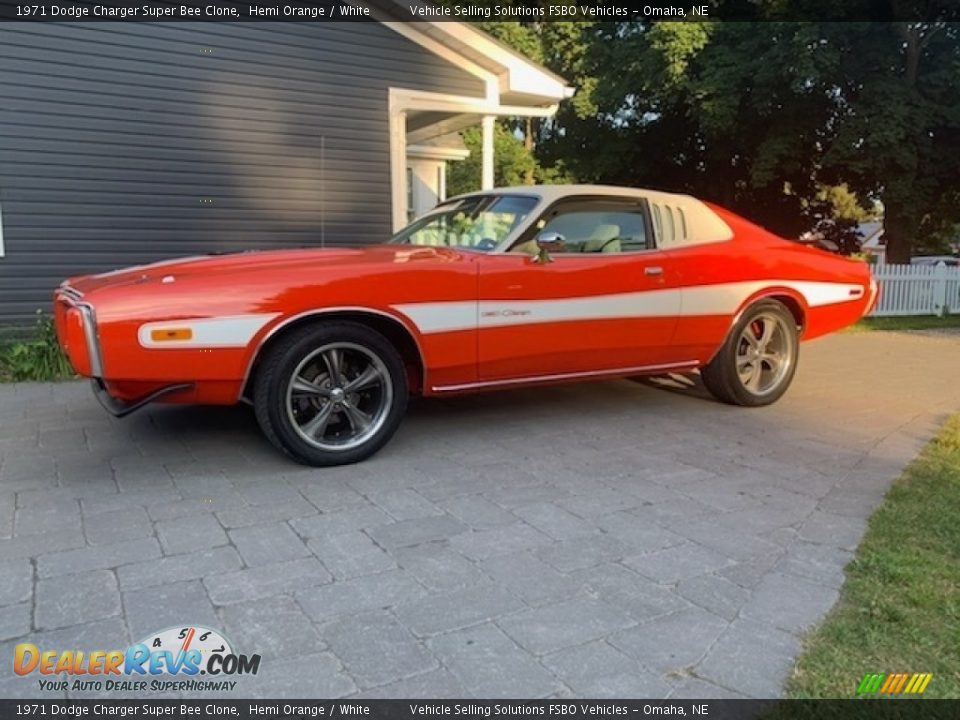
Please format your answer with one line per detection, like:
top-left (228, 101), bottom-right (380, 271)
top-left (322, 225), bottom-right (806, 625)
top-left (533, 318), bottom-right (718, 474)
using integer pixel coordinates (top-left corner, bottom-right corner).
top-left (13, 625), bottom-right (260, 692)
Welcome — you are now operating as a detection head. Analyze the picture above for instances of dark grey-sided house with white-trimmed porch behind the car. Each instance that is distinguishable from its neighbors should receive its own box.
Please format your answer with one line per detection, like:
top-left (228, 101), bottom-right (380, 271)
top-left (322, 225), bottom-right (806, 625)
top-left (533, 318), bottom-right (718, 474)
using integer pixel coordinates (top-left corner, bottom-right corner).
top-left (0, 0), bottom-right (573, 325)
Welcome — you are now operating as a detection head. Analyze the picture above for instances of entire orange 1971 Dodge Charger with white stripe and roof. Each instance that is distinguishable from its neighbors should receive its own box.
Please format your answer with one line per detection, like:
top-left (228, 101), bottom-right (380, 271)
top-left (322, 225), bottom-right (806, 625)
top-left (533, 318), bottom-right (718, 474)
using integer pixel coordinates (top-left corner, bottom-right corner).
top-left (55, 185), bottom-right (877, 465)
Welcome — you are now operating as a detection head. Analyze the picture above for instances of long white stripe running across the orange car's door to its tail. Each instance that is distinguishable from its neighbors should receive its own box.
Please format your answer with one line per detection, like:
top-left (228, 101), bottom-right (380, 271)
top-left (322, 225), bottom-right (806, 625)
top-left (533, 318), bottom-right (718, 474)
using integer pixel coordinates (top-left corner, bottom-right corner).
top-left (393, 280), bottom-right (864, 334)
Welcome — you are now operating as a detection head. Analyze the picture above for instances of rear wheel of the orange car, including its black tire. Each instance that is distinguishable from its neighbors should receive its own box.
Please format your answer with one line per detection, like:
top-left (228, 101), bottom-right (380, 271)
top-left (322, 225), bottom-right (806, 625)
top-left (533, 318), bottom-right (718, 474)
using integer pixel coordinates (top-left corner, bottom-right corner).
top-left (700, 300), bottom-right (800, 407)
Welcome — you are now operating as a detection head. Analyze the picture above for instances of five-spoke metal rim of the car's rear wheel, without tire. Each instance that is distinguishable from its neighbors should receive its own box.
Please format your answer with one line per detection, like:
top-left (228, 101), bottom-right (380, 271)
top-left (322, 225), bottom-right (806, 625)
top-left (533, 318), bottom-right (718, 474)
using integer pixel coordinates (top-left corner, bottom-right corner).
top-left (736, 313), bottom-right (795, 397)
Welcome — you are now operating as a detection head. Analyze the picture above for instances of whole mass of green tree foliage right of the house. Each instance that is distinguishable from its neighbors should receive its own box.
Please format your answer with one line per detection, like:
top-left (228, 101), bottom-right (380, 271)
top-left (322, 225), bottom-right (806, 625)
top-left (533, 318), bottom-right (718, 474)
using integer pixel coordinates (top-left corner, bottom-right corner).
top-left (472, 10), bottom-right (960, 261)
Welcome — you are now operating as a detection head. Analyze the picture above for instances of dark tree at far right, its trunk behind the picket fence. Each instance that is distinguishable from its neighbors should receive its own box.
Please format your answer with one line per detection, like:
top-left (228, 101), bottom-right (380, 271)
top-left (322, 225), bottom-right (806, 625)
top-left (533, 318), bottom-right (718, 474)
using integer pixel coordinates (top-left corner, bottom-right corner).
top-left (823, 22), bottom-right (960, 263)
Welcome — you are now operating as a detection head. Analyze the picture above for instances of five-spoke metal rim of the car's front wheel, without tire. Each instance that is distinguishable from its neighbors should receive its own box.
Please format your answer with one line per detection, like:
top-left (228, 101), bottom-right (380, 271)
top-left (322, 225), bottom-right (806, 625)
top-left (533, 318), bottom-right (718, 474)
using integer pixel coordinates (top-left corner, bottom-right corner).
top-left (286, 342), bottom-right (393, 452)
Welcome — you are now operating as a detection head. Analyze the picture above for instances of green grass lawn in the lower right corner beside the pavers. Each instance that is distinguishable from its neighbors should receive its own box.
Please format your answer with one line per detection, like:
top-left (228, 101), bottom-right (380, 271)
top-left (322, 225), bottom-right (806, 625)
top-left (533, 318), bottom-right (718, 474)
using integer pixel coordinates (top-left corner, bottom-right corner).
top-left (787, 415), bottom-right (960, 698)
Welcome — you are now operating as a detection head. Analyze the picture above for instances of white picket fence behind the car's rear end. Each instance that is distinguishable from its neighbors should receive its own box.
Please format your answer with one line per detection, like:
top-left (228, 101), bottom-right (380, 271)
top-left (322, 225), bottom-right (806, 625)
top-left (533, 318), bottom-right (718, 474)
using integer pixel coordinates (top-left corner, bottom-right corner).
top-left (871, 263), bottom-right (960, 317)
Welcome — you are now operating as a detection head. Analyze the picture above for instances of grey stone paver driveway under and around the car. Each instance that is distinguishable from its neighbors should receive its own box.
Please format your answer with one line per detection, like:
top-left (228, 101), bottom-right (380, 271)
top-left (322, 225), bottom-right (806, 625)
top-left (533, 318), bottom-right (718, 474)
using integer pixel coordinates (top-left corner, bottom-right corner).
top-left (0, 334), bottom-right (960, 697)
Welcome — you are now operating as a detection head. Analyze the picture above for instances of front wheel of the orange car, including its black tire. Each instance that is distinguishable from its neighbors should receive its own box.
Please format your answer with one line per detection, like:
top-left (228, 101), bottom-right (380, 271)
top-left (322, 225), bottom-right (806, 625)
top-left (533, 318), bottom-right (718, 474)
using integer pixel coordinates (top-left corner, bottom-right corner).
top-left (253, 322), bottom-right (408, 466)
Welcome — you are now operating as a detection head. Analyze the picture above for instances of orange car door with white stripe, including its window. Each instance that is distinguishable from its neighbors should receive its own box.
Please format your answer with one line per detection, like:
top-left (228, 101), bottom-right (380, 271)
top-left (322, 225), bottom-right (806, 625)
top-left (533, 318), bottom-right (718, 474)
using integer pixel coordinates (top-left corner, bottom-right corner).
top-left (477, 197), bottom-right (680, 381)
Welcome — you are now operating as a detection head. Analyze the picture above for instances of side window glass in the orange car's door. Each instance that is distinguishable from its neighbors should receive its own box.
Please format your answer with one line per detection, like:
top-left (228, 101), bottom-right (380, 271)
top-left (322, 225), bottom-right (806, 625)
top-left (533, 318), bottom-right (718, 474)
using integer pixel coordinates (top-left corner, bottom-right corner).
top-left (524, 206), bottom-right (649, 254)
